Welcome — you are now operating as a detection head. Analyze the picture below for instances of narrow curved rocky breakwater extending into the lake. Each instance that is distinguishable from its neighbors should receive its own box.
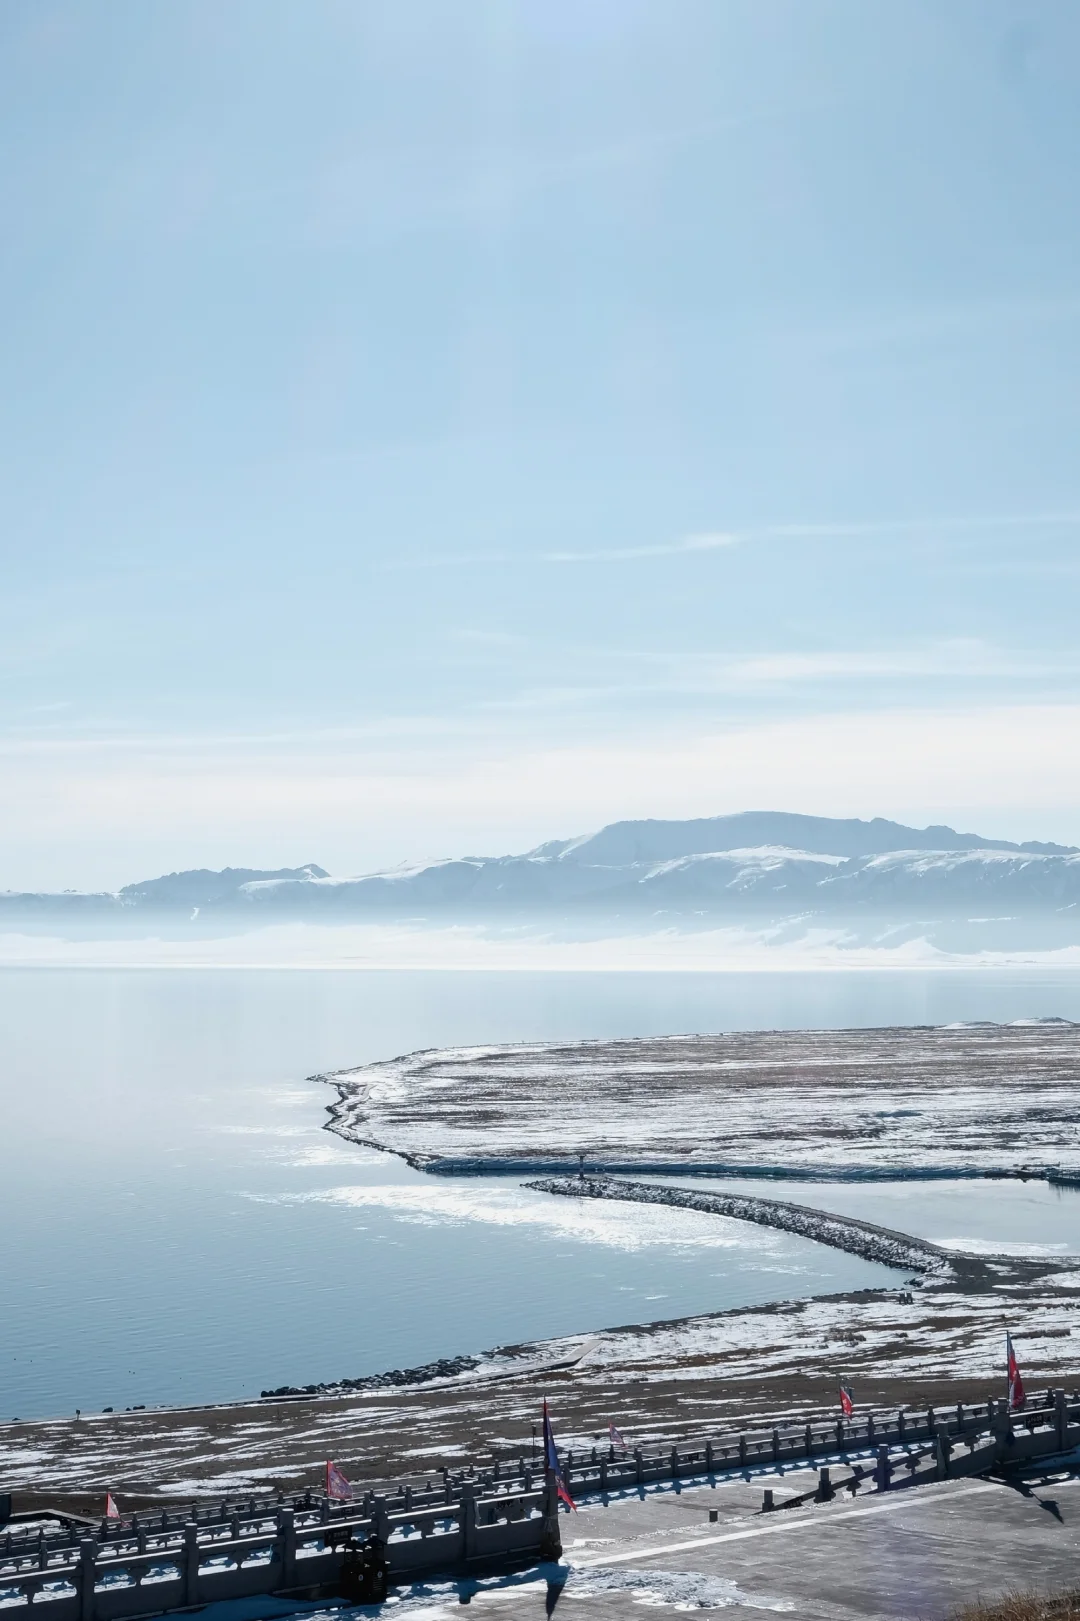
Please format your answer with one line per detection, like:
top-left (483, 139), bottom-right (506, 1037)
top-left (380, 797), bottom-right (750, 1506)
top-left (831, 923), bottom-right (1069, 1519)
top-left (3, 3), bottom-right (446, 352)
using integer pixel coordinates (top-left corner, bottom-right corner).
top-left (527, 1177), bottom-right (988, 1284)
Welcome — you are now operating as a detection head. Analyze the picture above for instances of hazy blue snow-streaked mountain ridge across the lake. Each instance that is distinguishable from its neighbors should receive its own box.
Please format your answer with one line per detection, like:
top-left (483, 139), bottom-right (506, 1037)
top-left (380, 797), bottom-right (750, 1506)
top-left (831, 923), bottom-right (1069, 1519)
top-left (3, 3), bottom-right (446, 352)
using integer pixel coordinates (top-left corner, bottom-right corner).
top-left (0, 811), bottom-right (1080, 927)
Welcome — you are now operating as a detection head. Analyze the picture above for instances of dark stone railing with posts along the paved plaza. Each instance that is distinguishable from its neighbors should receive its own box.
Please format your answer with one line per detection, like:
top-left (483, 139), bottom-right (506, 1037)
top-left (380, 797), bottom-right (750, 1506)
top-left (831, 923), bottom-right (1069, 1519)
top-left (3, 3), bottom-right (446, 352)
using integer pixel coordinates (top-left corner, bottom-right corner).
top-left (0, 1391), bottom-right (1080, 1621)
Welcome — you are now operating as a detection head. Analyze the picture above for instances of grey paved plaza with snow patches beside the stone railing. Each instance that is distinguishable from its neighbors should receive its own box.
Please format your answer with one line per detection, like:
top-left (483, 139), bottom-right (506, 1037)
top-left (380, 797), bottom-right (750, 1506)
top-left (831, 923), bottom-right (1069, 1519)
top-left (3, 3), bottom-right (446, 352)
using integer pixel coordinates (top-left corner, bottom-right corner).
top-left (366, 1472), bottom-right (1080, 1621)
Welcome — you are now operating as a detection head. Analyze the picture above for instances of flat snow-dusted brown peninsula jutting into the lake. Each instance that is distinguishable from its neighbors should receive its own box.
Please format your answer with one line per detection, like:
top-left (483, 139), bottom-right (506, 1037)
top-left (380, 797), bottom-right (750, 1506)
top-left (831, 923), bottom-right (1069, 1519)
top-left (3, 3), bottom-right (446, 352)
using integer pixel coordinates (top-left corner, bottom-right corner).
top-left (324, 1020), bottom-right (1080, 1175)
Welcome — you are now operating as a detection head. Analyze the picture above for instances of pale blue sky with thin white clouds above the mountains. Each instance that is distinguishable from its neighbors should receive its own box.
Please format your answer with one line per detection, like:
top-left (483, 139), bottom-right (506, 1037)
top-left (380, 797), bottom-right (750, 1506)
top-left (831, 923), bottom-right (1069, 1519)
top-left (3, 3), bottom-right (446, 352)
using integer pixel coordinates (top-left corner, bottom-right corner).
top-left (0, 0), bottom-right (1080, 887)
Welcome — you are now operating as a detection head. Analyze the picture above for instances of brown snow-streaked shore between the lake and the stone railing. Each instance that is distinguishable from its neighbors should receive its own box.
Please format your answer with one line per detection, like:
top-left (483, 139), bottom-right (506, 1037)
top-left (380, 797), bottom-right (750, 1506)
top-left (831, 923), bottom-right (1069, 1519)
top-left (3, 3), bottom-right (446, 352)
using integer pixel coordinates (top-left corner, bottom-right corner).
top-left (0, 1263), bottom-right (1080, 1506)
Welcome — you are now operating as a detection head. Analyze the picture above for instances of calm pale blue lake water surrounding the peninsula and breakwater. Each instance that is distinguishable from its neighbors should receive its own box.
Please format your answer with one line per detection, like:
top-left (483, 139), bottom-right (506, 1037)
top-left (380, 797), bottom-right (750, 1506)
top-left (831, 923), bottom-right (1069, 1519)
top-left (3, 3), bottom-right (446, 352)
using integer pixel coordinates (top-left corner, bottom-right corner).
top-left (0, 969), bottom-right (1080, 1417)
